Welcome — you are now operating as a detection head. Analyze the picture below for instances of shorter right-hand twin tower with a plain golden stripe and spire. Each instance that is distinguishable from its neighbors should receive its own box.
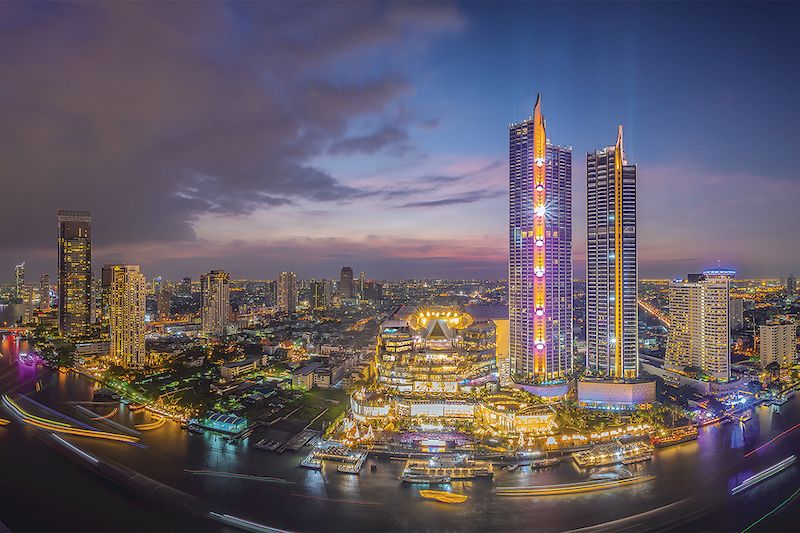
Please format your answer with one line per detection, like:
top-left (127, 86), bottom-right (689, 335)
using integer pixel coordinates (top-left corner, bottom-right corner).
top-left (586, 126), bottom-right (639, 379)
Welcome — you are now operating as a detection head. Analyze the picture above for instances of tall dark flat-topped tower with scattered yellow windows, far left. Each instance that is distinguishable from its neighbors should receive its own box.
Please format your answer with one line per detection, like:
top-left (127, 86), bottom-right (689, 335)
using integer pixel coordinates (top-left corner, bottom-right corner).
top-left (58, 210), bottom-right (92, 336)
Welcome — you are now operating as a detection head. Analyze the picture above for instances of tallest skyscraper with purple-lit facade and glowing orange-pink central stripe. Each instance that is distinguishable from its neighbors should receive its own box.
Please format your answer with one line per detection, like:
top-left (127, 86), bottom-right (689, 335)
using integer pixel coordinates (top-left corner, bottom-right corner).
top-left (508, 97), bottom-right (572, 397)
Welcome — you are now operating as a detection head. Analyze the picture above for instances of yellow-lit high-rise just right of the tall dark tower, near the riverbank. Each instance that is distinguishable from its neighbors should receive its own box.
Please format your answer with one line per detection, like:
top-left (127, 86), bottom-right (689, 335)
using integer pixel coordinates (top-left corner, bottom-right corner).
top-left (108, 264), bottom-right (147, 368)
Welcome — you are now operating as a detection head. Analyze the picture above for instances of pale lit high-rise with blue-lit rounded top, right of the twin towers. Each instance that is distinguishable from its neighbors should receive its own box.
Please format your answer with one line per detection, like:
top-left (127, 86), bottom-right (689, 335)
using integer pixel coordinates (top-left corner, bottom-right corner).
top-left (664, 274), bottom-right (731, 382)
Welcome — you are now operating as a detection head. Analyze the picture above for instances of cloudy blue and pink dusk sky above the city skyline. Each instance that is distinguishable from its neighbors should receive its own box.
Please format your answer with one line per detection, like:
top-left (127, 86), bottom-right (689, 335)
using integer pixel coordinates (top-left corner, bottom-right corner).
top-left (0, 2), bottom-right (800, 280)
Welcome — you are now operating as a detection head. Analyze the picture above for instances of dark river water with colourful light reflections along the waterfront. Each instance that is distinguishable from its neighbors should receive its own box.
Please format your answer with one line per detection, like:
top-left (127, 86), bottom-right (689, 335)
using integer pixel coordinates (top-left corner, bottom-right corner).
top-left (0, 338), bottom-right (800, 531)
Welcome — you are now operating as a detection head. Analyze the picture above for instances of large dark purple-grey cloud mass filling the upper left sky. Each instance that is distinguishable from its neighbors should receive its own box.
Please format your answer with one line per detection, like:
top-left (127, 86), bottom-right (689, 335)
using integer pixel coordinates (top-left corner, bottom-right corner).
top-left (0, 2), bottom-right (463, 260)
